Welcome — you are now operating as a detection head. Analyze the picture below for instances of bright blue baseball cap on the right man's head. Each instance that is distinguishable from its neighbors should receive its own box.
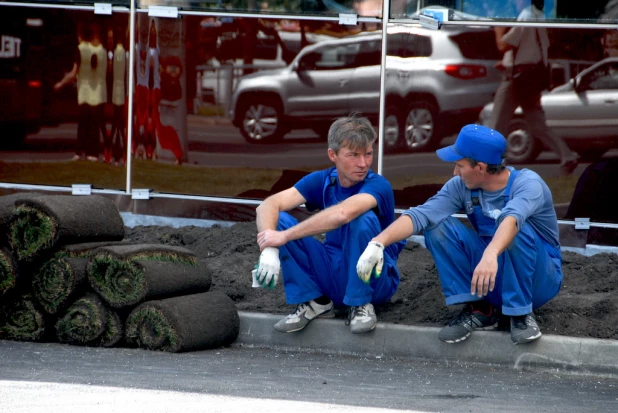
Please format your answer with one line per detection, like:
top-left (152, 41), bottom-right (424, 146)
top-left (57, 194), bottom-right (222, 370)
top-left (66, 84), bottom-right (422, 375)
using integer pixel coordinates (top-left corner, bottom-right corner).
top-left (436, 125), bottom-right (506, 165)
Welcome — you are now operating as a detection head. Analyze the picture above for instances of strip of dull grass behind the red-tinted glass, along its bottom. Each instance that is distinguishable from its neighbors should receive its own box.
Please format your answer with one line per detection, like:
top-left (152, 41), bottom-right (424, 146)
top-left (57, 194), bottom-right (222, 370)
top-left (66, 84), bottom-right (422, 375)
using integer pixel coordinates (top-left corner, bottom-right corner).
top-left (0, 159), bottom-right (578, 204)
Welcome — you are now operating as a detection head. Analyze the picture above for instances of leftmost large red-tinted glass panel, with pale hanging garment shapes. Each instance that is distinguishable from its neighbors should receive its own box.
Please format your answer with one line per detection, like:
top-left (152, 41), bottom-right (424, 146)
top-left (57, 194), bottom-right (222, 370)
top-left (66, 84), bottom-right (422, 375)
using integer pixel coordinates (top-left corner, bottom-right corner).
top-left (0, 6), bottom-right (129, 189)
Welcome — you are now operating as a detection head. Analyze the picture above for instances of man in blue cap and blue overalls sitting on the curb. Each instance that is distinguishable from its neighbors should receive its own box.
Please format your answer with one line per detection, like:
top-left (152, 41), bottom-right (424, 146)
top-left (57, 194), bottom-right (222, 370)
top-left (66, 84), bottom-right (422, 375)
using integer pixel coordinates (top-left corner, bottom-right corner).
top-left (357, 125), bottom-right (562, 344)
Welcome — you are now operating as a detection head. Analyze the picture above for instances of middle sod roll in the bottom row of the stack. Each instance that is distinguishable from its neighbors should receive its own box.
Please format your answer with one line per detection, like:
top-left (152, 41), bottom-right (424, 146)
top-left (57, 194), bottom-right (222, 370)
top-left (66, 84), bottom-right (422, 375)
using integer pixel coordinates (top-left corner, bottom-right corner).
top-left (56, 293), bottom-right (109, 345)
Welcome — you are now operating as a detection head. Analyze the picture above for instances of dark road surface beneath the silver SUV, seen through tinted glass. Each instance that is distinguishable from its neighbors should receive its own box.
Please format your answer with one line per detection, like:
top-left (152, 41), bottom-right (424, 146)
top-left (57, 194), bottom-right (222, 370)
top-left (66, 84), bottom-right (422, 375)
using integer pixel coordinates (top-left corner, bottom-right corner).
top-left (0, 116), bottom-right (585, 179)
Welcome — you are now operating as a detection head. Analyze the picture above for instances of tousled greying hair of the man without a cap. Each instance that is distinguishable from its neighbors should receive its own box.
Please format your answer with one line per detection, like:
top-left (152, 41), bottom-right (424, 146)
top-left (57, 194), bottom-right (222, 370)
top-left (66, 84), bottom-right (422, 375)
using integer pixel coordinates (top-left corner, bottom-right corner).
top-left (328, 113), bottom-right (378, 153)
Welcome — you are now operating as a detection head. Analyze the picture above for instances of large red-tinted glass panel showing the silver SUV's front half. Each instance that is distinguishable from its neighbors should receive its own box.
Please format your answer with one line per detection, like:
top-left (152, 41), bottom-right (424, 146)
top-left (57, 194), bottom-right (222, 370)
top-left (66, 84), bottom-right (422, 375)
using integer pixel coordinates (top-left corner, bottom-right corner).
top-left (132, 13), bottom-right (381, 198)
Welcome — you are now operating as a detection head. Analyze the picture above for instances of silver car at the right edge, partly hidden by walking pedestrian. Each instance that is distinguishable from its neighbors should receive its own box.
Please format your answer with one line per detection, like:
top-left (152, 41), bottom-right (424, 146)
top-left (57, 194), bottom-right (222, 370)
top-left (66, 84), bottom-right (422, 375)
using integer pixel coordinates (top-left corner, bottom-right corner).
top-left (480, 57), bottom-right (618, 163)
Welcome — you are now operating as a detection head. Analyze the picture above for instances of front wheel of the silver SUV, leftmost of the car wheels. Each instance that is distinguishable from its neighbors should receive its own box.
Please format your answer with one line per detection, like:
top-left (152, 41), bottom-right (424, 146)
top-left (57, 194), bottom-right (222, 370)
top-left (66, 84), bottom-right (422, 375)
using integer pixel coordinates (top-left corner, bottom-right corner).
top-left (240, 99), bottom-right (285, 143)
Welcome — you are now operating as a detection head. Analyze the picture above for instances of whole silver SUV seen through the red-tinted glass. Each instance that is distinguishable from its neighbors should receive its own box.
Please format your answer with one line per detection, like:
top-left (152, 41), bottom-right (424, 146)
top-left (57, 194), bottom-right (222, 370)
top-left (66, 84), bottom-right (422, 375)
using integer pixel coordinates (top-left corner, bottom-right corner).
top-left (230, 26), bottom-right (500, 151)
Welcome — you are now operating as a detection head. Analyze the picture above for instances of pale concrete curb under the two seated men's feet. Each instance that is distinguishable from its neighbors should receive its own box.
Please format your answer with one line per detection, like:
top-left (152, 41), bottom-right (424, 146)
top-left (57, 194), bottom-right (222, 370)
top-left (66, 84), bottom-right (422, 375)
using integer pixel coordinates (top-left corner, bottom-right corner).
top-left (236, 311), bottom-right (618, 377)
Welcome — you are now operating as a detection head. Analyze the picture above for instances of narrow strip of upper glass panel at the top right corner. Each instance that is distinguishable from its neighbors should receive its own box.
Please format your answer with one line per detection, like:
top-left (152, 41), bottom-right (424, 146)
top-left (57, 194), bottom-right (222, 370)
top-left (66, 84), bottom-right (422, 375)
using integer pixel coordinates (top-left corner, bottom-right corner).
top-left (390, 0), bottom-right (618, 24)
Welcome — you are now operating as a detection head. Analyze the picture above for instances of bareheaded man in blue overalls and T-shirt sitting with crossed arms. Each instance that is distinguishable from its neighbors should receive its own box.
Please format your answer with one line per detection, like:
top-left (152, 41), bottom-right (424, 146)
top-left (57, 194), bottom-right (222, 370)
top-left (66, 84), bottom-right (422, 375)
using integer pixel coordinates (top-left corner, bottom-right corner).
top-left (254, 116), bottom-right (404, 333)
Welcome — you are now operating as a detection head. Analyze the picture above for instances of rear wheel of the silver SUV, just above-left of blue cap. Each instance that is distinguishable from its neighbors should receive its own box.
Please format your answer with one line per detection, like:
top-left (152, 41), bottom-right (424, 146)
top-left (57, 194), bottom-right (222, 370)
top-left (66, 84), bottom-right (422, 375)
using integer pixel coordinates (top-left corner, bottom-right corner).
top-left (404, 102), bottom-right (440, 152)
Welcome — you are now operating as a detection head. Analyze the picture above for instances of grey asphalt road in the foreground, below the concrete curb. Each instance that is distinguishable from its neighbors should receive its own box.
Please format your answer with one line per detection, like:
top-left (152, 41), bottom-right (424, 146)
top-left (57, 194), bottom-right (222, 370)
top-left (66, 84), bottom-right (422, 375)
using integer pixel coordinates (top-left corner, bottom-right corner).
top-left (0, 341), bottom-right (618, 413)
